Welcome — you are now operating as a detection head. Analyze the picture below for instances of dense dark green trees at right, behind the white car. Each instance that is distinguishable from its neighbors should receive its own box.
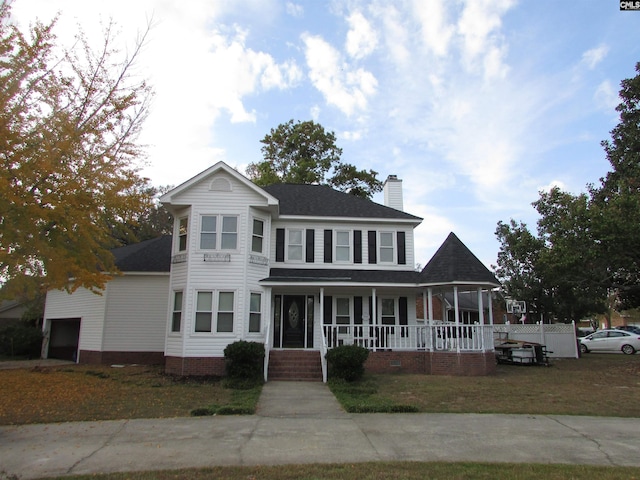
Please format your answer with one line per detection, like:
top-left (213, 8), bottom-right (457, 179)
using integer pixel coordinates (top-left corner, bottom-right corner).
top-left (496, 63), bottom-right (640, 321)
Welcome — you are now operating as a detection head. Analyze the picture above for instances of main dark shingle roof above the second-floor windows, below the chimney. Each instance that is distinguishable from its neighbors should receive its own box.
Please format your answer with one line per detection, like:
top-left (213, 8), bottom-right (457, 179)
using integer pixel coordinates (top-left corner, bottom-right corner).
top-left (263, 183), bottom-right (422, 222)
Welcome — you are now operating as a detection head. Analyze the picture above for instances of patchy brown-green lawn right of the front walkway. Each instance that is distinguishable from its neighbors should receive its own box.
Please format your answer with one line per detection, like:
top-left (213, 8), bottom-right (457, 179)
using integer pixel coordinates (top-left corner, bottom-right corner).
top-left (330, 354), bottom-right (640, 417)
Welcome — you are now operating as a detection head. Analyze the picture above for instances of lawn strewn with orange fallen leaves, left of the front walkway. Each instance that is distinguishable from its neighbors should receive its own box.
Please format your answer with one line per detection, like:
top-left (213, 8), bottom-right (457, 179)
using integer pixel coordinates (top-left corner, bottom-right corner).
top-left (0, 365), bottom-right (261, 425)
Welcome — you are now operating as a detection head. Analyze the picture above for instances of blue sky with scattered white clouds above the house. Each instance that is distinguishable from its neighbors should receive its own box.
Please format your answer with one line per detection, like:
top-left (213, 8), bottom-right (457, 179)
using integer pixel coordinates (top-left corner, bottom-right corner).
top-left (13, 0), bottom-right (640, 266)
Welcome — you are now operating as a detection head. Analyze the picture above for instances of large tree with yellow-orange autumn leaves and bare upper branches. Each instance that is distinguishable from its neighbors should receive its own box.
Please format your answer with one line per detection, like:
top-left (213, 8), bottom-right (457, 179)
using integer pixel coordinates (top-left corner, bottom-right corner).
top-left (0, 2), bottom-right (151, 296)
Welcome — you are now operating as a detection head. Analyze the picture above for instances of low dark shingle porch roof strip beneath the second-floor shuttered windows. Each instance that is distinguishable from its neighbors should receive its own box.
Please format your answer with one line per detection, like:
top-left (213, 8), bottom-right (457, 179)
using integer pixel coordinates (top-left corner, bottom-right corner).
top-left (263, 268), bottom-right (418, 284)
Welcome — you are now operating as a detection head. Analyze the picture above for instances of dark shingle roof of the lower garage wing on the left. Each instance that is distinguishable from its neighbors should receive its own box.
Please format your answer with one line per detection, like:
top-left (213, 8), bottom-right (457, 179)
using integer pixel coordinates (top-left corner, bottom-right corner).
top-left (111, 235), bottom-right (171, 272)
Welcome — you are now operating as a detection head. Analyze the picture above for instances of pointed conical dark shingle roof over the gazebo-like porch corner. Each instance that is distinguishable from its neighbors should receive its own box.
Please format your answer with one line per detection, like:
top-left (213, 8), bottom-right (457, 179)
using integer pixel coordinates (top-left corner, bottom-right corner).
top-left (420, 232), bottom-right (500, 286)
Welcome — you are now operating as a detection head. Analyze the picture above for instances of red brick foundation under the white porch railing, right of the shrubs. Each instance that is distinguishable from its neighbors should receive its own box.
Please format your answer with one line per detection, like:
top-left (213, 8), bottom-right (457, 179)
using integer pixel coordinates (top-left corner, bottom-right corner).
top-left (365, 351), bottom-right (496, 376)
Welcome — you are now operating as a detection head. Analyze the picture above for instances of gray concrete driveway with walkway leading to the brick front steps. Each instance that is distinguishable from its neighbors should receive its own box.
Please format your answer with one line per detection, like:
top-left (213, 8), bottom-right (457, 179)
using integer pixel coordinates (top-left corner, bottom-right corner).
top-left (0, 382), bottom-right (640, 479)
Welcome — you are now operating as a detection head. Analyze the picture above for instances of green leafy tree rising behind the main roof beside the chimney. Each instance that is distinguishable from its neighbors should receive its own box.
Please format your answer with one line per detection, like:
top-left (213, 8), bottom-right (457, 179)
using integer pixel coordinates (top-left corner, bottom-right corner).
top-left (246, 120), bottom-right (382, 198)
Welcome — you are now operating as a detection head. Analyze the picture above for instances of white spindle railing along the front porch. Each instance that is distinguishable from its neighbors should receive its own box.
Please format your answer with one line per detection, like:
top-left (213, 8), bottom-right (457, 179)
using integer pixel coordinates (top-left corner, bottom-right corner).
top-left (323, 323), bottom-right (493, 352)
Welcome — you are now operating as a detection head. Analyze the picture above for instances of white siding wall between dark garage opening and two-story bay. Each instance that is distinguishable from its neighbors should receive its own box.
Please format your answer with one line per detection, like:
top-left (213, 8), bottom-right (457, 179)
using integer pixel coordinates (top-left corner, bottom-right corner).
top-left (103, 275), bottom-right (169, 352)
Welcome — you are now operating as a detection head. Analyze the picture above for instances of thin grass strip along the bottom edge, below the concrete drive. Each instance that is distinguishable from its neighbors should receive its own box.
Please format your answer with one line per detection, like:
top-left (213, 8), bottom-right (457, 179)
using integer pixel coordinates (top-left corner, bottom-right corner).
top-left (31, 462), bottom-right (640, 480)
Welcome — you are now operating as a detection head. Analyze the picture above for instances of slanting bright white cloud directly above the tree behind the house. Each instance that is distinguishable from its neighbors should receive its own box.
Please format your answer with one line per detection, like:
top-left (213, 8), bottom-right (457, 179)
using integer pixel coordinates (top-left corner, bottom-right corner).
top-left (302, 33), bottom-right (378, 116)
